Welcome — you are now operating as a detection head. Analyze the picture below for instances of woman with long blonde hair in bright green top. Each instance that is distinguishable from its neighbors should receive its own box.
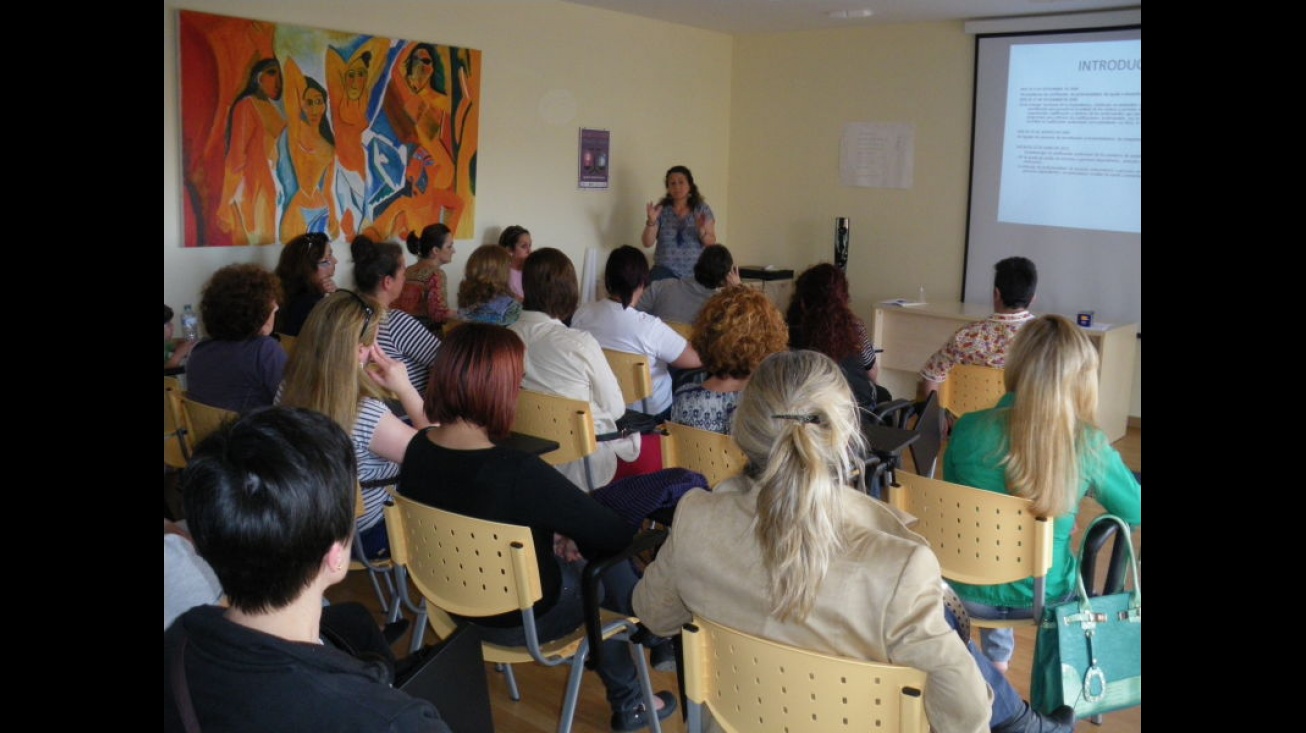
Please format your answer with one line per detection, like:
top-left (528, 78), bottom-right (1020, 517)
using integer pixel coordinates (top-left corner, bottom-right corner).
top-left (943, 315), bottom-right (1143, 670)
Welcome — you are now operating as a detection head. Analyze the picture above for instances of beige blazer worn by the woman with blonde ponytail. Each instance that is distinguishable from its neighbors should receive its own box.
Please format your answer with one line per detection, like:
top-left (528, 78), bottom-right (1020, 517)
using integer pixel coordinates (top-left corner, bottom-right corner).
top-left (633, 477), bottom-right (993, 733)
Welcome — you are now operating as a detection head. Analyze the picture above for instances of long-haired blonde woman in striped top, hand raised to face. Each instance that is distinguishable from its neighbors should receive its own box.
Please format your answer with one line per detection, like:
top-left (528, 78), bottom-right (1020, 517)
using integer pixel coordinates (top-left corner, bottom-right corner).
top-left (277, 290), bottom-right (427, 558)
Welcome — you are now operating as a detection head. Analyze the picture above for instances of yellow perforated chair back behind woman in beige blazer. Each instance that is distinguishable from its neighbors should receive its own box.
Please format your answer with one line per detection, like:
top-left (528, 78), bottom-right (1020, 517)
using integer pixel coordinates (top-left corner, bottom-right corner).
top-left (680, 617), bottom-right (930, 733)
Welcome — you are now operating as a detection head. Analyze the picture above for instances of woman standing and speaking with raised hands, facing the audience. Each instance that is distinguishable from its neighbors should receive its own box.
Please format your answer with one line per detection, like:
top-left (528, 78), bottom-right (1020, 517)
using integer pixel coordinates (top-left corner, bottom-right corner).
top-left (640, 166), bottom-right (717, 280)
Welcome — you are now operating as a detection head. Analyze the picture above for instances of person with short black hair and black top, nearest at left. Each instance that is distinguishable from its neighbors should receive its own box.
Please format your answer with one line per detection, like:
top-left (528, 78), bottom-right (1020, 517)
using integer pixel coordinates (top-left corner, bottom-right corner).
top-left (163, 408), bottom-right (449, 733)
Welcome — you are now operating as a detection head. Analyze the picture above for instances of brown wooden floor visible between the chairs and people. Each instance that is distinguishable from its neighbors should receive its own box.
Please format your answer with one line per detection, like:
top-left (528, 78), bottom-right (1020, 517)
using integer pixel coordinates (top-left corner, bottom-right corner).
top-left (327, 426), bottom-right (1143, 733)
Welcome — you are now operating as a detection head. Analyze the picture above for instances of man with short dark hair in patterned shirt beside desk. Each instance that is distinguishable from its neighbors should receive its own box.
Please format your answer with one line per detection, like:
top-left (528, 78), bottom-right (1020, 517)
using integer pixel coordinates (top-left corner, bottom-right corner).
top-left (921, 257), bottom-right (1038, 399)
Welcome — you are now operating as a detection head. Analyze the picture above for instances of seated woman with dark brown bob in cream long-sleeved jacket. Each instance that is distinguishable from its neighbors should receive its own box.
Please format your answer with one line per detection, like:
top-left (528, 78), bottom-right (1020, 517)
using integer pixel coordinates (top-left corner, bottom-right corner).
top-left (508, 247), bottom-right (639, 491)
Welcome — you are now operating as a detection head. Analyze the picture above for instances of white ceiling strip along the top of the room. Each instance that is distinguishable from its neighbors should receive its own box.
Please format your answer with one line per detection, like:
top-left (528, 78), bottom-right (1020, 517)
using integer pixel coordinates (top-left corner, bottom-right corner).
top-left (565, 0), bottom-right (1143, 35)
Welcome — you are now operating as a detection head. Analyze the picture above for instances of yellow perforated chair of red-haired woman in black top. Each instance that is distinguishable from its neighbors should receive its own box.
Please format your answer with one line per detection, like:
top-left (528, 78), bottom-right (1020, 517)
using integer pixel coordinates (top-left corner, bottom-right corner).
top-left (385, 495), bottom-right (665, 733)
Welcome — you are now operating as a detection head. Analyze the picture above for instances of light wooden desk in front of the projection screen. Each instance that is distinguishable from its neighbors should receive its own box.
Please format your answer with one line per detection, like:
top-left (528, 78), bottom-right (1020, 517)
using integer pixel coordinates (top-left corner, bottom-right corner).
top-left (871, 302), bottom-right (1139, 442)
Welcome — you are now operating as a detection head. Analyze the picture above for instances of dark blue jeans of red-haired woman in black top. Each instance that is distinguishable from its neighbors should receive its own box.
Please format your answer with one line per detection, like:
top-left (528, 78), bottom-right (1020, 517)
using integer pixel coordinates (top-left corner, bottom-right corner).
top-left (477, 555), bottom-right (641, 712)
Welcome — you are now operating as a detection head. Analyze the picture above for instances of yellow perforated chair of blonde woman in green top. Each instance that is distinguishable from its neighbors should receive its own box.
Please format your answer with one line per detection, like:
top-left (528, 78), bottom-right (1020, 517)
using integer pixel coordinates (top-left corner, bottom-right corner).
top-left (889, 470), bottom-right (1053, 628)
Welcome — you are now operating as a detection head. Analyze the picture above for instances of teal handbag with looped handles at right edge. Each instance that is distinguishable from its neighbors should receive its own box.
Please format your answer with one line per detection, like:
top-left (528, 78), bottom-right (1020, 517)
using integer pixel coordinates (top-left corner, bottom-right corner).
top-left (1029, 515), bottom-right (1143, 719)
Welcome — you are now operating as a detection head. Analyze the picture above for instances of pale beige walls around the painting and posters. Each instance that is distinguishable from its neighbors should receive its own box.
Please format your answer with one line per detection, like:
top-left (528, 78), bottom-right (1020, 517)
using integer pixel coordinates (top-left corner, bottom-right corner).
top-left (163, 0), bottom-right (1143, 417)
